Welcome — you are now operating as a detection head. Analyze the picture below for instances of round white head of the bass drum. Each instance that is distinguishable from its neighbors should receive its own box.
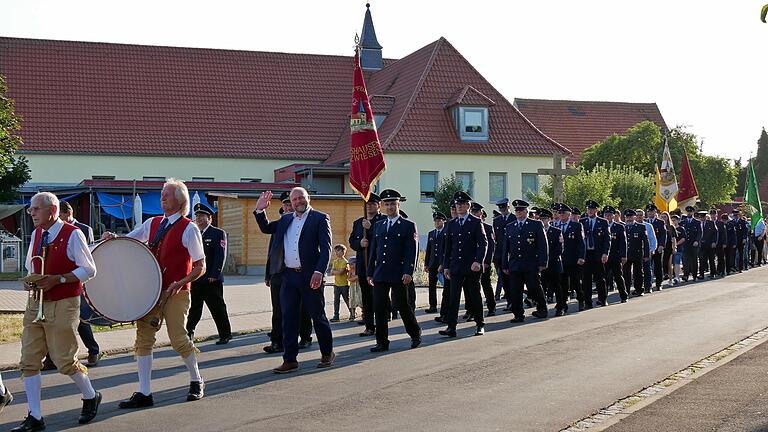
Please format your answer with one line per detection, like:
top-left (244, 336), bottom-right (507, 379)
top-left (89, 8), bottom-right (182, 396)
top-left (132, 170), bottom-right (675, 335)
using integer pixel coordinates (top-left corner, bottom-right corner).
top-left (85, 237), bottom-right (162, 322)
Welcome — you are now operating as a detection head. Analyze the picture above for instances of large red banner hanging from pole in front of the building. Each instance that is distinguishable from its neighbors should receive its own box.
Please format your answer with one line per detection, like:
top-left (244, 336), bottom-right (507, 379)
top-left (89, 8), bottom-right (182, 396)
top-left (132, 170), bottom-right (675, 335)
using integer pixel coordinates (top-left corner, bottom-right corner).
top-left (349, 53), bottom-right (387, 202)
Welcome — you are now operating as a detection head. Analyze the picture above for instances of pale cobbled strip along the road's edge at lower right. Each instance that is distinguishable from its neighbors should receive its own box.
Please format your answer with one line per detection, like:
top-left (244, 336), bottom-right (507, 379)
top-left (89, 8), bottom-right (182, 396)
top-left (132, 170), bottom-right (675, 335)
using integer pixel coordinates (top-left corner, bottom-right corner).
top-left (561, 327), bottom-right (768, 432)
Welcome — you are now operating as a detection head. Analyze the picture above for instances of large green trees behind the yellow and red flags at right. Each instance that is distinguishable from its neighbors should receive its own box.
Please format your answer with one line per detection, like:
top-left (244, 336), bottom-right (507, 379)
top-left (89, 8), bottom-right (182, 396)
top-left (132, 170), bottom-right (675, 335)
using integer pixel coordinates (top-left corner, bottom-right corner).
top-left (579, 121), bottom-right (738, 206)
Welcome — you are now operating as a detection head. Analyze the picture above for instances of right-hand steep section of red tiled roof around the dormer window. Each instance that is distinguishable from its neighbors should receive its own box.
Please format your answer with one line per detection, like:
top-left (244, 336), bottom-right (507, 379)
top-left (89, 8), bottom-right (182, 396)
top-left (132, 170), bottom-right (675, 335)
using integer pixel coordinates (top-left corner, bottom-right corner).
top-left (326, 38), bottom-right (569, 162)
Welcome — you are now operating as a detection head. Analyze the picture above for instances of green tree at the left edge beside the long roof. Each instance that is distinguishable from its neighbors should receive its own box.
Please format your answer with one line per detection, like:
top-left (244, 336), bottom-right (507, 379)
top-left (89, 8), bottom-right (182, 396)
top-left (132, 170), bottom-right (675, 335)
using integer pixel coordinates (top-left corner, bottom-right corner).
top-left (0, 75), bottom-right (31, 201)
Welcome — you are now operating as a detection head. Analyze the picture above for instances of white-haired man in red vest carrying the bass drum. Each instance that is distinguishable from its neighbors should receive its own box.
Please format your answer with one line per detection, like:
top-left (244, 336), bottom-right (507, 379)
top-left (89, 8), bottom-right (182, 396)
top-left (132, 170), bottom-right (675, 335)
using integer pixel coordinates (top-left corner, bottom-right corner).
top-left (102, 179), bottom-right (205, 409)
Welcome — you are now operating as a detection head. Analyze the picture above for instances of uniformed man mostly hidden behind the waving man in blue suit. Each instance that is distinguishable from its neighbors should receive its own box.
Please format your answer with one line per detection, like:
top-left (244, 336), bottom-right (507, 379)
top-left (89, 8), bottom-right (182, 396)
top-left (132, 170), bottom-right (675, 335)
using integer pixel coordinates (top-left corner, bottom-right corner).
top-left (253, 191), bottom-right (312, 354)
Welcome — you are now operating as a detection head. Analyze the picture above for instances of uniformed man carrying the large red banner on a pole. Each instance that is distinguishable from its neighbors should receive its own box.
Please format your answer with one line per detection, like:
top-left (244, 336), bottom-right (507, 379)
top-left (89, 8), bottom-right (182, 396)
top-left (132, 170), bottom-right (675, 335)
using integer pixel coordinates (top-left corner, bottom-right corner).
top-left (349, 192), bottom-right (385, 337)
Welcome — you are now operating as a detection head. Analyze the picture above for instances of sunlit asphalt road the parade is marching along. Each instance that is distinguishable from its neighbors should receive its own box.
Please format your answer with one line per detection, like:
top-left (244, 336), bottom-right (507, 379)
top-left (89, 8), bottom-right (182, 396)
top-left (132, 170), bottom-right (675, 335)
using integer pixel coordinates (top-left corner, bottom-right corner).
top-left (0, 268), bottom-right (768, 432)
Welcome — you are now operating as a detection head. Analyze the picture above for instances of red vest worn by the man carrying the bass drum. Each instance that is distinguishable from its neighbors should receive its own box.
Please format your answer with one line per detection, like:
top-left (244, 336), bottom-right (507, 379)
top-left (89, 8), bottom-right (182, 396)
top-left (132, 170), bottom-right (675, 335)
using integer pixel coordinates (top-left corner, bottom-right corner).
top-left (149, 216), bottom-right (192, 290)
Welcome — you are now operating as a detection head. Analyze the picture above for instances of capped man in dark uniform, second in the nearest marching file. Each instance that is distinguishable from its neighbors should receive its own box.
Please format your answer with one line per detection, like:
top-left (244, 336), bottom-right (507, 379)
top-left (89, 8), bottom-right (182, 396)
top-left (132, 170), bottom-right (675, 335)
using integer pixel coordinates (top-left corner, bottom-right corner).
top-left (439, 191), bottom-right (488, 337)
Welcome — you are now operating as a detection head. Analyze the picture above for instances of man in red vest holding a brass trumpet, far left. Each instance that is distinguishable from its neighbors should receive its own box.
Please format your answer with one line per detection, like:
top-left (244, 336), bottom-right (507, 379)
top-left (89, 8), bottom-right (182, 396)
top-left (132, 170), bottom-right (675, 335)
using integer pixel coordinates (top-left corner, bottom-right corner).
top-left (13, 192), bottom-right (101, 432)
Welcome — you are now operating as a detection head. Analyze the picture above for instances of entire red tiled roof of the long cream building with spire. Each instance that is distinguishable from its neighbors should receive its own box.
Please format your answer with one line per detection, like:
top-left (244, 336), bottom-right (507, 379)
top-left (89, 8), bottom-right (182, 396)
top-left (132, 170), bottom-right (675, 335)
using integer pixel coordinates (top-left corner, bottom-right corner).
top-left (0, 37), bottom-right (567, 163)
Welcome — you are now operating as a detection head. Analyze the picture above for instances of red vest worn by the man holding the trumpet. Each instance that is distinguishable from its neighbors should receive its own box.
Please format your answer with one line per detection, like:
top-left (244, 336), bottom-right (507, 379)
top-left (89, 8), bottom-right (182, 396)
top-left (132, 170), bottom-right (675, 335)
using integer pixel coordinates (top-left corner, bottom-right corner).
top-left (32, 223), bottom-right (83, 301)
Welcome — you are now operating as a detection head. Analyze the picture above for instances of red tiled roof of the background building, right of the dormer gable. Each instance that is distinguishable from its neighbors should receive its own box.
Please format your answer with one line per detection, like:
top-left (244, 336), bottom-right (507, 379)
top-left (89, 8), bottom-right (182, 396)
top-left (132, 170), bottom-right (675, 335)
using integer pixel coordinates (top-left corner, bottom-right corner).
top-left (515, 98), bottom-right (667, 163)
